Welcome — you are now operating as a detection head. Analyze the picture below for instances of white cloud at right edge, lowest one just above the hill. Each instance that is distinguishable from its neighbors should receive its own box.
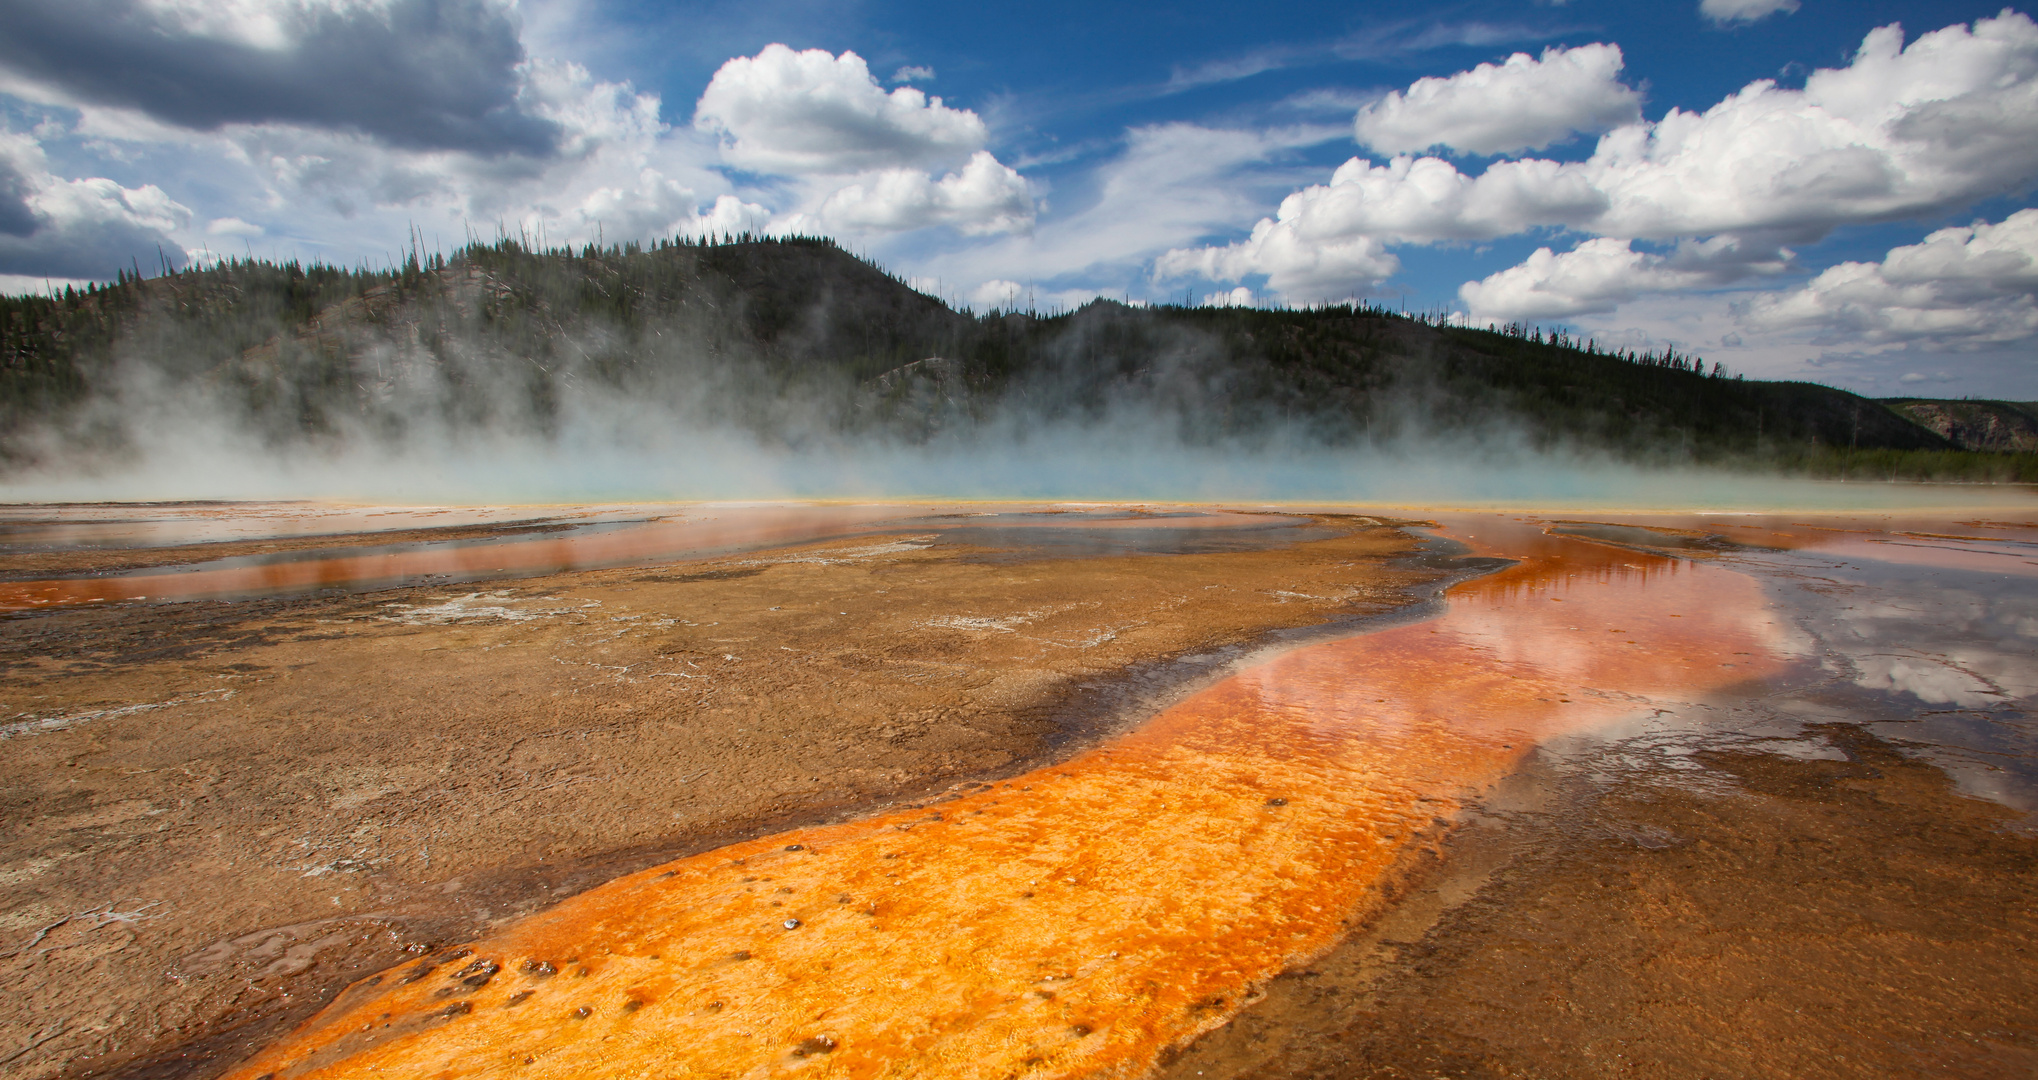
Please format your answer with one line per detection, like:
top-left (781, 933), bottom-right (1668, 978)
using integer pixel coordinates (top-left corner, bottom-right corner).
top-left (1740, 210), bottom-right (2038, 348)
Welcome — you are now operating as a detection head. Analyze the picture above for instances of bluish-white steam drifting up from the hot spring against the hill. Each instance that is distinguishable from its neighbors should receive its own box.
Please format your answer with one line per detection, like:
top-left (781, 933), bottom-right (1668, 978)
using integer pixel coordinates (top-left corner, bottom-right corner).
top-left (0, 260), bottom-right (2028, 509)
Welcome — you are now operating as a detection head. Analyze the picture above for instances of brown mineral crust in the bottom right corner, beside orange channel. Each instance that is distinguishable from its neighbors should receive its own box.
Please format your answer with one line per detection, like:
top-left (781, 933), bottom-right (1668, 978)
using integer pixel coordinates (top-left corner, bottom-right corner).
top-left (1162, 723), bottom-right (2038, 1080)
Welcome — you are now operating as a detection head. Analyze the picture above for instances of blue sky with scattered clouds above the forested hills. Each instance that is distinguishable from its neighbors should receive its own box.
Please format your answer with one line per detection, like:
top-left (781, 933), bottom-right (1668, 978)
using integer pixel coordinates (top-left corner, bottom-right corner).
top-left (0, 0), bottom-right (2038, 399)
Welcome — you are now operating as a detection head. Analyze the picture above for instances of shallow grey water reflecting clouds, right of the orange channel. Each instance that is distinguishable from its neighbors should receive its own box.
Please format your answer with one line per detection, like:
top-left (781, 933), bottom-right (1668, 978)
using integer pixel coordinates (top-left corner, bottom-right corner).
top-left (1559, 520), bottom-right (2038, 815)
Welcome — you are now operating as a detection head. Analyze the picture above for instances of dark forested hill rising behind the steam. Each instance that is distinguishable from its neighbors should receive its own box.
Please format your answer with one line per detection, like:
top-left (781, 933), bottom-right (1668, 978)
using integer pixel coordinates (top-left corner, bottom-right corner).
top-left (0, 238), bottom-right (2038, 481)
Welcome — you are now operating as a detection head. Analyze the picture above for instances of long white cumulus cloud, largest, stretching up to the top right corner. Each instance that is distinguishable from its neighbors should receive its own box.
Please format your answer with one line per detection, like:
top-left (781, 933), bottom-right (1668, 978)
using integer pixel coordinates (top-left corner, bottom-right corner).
top-left (1156, 12), bottom-right (2038, 300)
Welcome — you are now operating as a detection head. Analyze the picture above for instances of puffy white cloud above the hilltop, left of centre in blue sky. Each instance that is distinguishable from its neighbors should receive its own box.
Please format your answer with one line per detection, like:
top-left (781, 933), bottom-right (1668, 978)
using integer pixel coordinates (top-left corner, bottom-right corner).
top-left (693, 45), bottom-right (988, 175)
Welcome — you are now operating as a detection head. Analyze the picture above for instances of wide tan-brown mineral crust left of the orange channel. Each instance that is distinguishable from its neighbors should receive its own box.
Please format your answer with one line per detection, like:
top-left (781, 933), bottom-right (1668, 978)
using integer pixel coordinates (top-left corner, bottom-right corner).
top-left (0, 516), bottom-right (1435, 1076)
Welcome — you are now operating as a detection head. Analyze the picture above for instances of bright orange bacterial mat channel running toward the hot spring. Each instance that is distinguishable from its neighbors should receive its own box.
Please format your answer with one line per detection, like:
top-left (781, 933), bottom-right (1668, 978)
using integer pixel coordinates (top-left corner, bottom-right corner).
top-left (219, 518), bottom-right (1789, 1080)
